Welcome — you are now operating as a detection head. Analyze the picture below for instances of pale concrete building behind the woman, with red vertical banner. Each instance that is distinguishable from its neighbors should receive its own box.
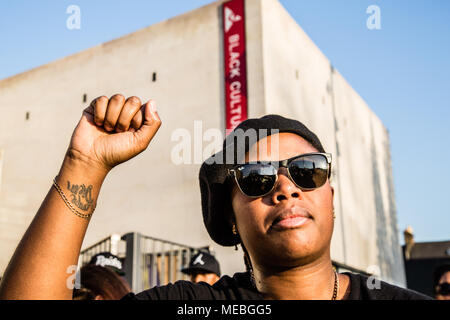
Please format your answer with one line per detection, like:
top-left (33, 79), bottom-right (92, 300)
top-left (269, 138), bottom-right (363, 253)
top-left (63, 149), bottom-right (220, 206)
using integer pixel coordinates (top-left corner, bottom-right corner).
top-left (0, 0), bottom-right (405, 284)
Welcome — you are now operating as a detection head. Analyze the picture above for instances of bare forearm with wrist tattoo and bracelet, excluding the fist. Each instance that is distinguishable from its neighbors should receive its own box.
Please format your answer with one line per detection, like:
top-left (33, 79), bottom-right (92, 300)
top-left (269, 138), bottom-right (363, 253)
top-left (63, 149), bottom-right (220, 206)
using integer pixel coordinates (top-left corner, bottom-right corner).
top-left (0, 153), bottom-right (106, 299)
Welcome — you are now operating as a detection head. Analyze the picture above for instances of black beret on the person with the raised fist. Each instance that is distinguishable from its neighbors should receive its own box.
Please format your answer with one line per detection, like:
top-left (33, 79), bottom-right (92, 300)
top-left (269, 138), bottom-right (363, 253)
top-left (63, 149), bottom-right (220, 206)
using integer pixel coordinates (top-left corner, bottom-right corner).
top-left (199, 115), bottom-right (325, 246)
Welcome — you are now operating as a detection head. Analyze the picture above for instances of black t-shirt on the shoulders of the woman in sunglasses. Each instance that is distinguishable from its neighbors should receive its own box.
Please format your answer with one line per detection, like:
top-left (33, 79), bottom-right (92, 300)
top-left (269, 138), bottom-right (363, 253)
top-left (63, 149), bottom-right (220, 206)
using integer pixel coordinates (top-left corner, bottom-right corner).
top-left (122, 272), bottom-right (431, 300)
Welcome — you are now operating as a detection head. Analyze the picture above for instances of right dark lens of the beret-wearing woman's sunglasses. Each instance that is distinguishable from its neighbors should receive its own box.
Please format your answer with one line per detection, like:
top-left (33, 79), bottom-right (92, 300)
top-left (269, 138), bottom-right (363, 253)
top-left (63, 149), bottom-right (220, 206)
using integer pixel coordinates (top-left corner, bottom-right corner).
top-left (289, 154), bottom-right (328, 189)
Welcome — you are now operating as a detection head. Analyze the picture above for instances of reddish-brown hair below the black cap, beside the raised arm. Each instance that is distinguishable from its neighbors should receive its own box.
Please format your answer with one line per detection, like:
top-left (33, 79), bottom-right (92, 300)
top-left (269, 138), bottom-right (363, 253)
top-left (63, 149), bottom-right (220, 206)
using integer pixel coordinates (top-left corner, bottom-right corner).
top-left (73, 264), bottom-right (131, 300)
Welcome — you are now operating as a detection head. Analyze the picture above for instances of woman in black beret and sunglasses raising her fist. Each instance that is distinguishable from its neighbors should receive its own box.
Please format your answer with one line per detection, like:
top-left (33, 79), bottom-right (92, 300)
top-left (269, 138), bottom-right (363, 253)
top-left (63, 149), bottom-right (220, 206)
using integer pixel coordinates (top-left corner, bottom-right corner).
top-left (0, 95), bottom-right (427, 300)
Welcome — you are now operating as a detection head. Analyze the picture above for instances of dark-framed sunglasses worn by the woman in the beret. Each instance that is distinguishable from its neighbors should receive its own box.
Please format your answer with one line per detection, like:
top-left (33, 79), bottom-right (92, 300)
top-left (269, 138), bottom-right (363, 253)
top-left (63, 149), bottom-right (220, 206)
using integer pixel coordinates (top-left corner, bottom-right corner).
top-left (228, 153), bottom-right (331, 198)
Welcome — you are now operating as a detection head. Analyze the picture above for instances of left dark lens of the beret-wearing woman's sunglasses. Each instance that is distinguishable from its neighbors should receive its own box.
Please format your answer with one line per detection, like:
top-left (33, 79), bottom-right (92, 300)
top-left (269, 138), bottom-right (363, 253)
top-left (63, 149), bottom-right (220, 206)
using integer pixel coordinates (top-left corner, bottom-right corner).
top-left (236, 163), bottom-right (277, 197)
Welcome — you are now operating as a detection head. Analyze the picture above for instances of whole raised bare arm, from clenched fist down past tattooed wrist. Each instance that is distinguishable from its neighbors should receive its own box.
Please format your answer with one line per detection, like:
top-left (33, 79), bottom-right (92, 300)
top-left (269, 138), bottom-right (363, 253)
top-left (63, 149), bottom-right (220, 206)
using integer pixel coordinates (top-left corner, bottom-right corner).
top-left (0, 95), bottom-right (161, 299)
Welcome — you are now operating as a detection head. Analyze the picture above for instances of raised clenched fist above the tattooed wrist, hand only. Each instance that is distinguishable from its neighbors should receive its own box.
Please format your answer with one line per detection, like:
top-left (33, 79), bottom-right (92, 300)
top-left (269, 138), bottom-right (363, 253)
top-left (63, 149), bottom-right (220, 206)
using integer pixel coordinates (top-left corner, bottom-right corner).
top-left (68, 94), bottom-right (161, 171)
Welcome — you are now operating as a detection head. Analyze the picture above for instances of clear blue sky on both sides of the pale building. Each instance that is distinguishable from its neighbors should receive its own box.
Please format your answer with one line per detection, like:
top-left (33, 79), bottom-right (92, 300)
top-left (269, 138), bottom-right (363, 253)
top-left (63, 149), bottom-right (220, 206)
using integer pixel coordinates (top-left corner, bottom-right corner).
top-left (0, 0), bottom-right (450, 241)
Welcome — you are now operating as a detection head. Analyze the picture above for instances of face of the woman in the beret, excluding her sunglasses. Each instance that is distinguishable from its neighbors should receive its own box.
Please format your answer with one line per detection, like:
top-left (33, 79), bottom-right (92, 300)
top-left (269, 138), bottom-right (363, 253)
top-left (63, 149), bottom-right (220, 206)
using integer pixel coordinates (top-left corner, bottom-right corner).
top-left (231, 133), bottom-right (334, 268)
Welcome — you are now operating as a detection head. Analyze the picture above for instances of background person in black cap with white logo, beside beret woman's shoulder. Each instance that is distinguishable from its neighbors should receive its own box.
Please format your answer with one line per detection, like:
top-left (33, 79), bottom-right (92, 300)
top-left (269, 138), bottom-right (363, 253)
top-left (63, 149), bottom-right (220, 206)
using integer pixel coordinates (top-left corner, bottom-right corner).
top-left (181, 251), bottom-right (220, 286)
